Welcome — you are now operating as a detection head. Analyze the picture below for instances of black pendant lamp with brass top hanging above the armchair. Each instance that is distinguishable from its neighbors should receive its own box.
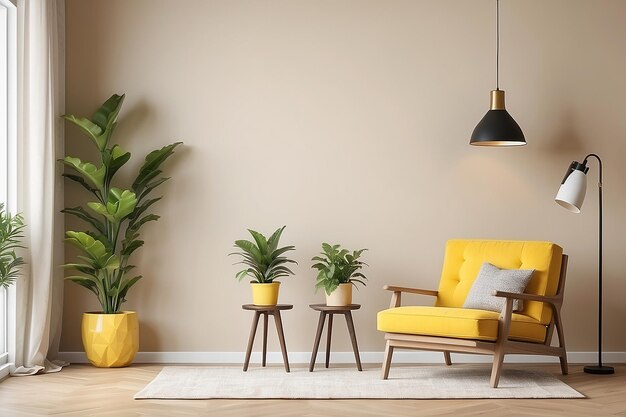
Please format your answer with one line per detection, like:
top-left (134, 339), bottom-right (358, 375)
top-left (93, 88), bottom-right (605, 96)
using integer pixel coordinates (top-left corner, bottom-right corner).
top-left (470, 0), bottom-right (526, 146)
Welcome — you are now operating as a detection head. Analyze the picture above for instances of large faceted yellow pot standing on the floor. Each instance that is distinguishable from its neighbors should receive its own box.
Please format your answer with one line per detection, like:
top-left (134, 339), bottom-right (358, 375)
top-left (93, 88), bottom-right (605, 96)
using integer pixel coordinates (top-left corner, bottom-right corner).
top-left (82, 311), bottom-right (139, 368)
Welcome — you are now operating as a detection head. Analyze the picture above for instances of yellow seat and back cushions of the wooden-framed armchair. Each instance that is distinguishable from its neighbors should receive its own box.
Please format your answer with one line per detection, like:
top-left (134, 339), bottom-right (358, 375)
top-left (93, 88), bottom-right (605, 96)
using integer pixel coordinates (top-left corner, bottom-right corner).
top-left (378, 240), bottom-right (563, 343)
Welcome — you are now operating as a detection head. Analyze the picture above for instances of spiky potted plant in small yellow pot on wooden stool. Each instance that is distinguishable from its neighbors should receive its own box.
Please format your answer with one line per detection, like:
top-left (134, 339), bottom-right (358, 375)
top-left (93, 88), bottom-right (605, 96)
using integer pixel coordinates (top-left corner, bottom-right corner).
top-left (230, 226), bottom-right (297, 306)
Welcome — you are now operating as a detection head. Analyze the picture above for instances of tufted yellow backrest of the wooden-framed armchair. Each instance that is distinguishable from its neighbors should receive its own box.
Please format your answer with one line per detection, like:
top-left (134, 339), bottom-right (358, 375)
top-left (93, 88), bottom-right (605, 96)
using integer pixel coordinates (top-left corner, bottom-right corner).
top-left (435, 239), bottom-right (563, 325)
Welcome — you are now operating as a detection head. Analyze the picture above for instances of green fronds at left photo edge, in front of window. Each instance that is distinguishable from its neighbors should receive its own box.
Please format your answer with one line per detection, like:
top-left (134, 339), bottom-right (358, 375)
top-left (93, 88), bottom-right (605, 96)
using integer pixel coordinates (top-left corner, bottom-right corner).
top-left (0, 203), bottom-right (25, 288)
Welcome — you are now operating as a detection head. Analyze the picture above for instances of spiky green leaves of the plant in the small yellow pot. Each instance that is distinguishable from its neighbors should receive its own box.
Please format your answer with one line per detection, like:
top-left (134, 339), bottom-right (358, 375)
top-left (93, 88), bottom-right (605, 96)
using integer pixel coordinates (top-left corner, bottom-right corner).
top-left (230, 226), bottom-right (297, 284)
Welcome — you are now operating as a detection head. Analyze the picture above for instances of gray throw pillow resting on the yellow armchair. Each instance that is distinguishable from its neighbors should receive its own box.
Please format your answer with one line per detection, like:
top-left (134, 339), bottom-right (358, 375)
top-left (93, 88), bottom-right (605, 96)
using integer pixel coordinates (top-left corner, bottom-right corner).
top-left (463, 262), bottom-right (535, 312)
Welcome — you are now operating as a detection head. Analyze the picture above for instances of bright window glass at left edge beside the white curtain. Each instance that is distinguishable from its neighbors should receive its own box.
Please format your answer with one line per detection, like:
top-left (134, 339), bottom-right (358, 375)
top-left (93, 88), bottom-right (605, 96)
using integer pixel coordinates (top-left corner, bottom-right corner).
top-left (0, 0), bottom-right (17, 378)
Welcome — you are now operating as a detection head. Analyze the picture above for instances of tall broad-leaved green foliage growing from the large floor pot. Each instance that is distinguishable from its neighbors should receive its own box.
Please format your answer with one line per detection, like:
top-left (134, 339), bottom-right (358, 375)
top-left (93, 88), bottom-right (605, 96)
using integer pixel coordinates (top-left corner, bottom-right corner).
top-left (62, 94), bottom-right (182, 314)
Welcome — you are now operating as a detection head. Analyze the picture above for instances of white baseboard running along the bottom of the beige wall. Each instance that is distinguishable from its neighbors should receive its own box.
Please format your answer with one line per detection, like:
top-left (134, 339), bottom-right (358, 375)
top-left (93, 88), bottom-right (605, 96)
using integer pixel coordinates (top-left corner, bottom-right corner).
top-left (58, 351), bottom-right (626, 364)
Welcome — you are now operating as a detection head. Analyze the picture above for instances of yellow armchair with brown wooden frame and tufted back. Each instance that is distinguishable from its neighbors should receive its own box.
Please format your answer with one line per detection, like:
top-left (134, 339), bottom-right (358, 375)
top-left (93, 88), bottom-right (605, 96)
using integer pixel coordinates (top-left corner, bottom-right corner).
top-left (378, 240), bottom-right (567, 388)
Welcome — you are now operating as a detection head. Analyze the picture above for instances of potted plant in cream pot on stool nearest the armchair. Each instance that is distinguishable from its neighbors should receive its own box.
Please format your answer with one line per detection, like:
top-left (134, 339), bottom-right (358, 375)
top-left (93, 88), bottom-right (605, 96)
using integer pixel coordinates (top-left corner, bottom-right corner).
top-left (311, 243), bottom-right (367, 306)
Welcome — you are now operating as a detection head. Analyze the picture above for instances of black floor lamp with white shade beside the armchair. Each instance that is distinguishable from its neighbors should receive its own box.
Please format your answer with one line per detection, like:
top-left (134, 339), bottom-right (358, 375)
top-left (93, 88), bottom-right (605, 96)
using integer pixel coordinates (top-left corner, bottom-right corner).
top-left (554, 153), bottom-right (615, 375)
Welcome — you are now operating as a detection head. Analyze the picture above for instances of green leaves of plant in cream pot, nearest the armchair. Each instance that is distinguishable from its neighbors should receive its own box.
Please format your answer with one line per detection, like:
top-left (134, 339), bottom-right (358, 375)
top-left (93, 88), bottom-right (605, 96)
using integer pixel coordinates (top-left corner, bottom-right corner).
top-left (311, 243), bottom-right (367, 295)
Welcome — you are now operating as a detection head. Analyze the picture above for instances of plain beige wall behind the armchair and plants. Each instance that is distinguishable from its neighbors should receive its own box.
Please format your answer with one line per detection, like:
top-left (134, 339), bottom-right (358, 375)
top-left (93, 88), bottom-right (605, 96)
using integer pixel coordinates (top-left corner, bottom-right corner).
top-left (61, 0), bottom-right (626, 351)
